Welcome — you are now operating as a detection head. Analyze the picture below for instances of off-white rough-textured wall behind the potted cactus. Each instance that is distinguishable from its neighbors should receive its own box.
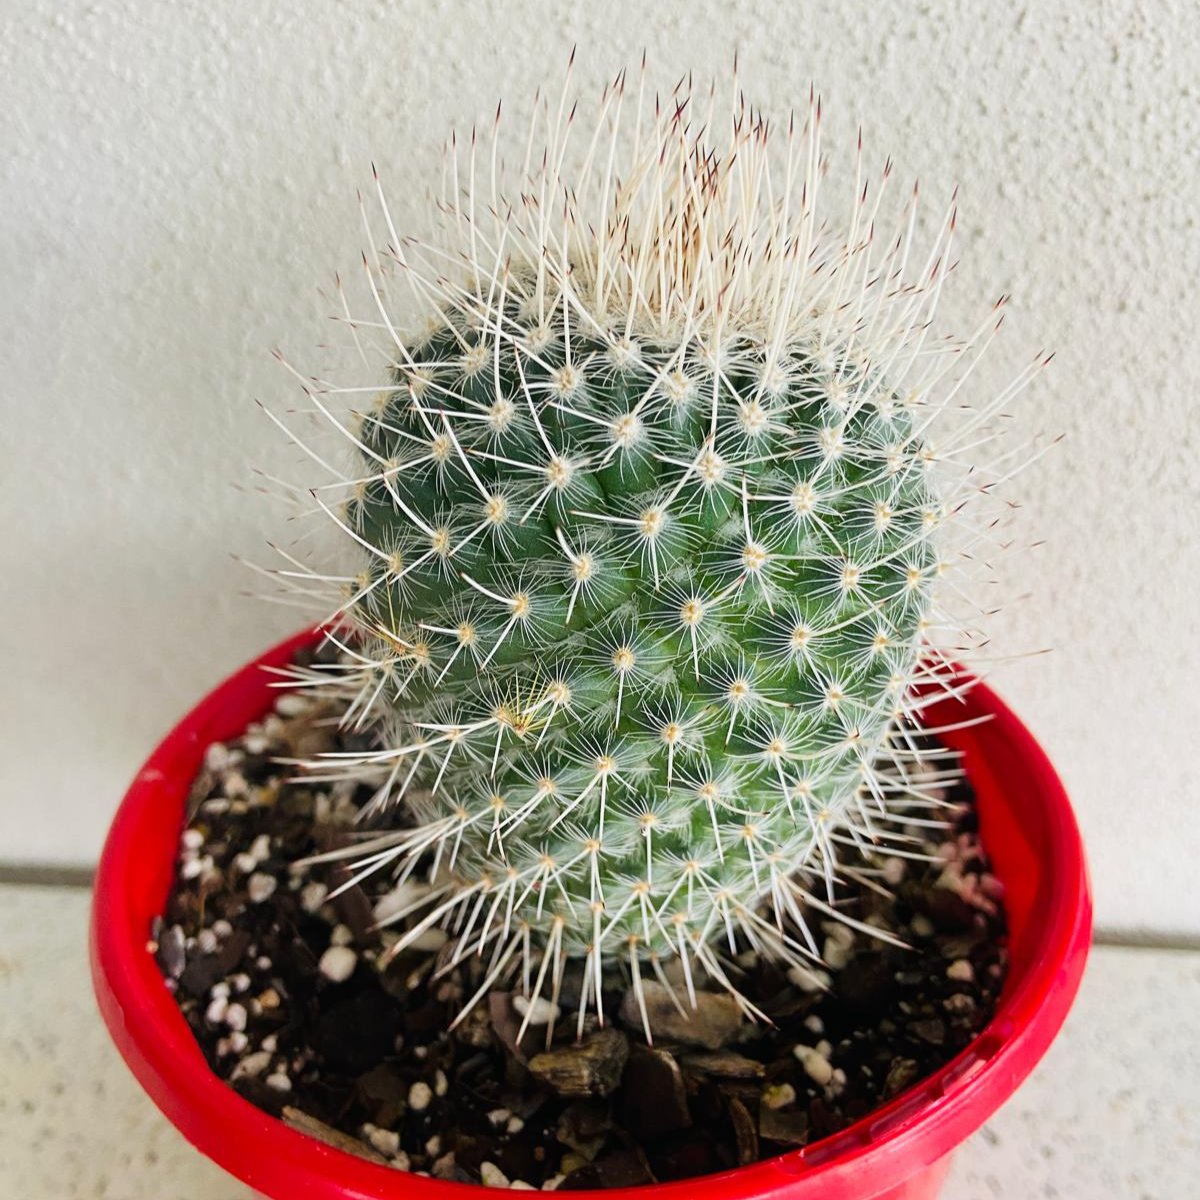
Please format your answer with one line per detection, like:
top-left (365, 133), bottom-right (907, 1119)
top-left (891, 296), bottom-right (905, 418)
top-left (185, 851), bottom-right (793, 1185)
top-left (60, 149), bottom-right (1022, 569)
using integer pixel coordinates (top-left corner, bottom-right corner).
top-left (0, 0), bottom-right (1200, 934)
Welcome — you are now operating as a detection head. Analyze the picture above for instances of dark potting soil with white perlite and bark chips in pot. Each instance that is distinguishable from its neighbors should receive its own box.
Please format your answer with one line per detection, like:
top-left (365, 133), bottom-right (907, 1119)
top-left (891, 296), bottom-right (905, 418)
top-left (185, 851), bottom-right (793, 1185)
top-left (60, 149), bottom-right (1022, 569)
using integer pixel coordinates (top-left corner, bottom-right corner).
top-left (152, 657), bottom-right (1007, 1189)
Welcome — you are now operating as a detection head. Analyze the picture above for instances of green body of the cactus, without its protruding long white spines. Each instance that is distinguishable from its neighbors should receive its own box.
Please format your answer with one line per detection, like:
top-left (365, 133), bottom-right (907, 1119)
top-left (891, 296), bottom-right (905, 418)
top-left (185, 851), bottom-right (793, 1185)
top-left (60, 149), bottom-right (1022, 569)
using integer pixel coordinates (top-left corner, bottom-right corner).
top-left (336, 302), bottom-right (938, 954)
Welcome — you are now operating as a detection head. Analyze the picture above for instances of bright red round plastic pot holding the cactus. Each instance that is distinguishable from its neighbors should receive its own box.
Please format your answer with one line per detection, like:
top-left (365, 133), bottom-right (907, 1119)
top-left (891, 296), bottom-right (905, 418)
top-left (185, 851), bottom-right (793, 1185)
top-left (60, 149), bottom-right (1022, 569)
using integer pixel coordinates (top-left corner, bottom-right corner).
top-left (91, 631), bottom-right (1092, 1200)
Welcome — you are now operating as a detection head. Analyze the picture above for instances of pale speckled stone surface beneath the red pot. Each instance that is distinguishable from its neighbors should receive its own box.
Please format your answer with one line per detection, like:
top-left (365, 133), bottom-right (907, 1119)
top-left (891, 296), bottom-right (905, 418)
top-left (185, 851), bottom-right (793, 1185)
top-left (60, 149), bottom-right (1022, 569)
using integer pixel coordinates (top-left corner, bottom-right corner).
top-left (0, 887), bottom-right (1200, 1200)
